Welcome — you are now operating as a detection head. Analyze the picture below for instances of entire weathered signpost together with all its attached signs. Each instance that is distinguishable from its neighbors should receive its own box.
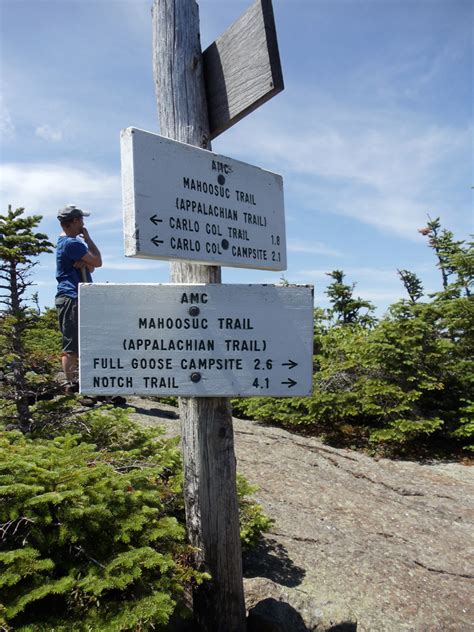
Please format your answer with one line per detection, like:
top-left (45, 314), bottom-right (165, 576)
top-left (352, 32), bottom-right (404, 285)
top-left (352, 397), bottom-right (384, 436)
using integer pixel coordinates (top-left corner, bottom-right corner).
top-left (80, 0), bottom-right (296, 632)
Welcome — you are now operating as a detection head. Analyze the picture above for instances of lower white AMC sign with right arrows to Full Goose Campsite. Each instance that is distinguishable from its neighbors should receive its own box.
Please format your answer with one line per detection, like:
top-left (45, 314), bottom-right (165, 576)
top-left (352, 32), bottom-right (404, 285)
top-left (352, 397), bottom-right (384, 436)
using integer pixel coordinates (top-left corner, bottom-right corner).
top-left (79, 284), bottom-right (313, 397)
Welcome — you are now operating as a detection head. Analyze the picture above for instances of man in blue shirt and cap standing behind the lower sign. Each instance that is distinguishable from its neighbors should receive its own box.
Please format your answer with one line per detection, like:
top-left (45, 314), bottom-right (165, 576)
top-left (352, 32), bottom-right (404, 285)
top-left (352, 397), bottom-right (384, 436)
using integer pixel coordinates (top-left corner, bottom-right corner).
top-left (55, 204), bottom-right (102, 392)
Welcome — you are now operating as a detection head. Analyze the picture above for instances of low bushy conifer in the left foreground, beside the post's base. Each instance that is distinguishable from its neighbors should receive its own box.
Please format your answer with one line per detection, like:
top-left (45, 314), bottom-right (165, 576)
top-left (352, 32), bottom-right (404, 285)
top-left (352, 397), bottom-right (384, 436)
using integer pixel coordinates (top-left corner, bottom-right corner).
top-left (0, 409), bottom-right (205, 632)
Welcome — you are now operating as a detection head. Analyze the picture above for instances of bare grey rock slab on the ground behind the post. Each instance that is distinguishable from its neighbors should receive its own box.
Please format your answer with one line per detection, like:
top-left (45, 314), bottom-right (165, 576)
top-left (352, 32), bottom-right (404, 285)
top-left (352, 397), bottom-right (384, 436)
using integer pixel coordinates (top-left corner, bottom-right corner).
top-left (129, 398), bottom-right (474, 632)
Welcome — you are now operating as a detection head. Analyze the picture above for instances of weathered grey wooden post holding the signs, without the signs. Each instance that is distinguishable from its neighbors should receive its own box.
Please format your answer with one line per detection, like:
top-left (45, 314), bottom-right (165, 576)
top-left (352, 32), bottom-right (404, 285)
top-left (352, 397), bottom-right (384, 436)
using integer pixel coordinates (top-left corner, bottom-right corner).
top-left (152, 0), bottom-right (246, 632)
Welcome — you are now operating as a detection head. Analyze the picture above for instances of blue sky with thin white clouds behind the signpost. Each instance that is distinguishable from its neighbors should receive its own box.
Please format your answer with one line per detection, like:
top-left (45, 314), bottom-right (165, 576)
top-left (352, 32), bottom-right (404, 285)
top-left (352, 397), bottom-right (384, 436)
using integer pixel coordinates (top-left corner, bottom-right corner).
top-left (0, 0), bottom-right (474, 314)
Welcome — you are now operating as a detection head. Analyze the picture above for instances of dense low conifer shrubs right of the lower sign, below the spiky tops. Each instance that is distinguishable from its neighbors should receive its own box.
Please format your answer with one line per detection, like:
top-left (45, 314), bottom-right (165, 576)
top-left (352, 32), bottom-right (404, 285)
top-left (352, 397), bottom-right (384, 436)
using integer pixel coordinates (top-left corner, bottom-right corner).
top-left (233, 297), bottom-right (474, 454)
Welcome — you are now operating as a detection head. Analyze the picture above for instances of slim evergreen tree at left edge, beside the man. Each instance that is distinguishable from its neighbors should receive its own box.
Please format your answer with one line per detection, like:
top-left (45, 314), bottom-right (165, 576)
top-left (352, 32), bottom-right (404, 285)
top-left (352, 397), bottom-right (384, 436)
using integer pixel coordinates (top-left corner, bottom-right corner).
top-left (0, 206), bottom-right (53, 432)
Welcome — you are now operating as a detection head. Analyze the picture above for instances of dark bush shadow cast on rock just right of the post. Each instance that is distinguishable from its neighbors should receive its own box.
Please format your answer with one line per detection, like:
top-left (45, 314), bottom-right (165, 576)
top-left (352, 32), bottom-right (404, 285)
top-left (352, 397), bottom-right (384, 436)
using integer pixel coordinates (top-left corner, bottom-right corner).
top-left (243, 539), bottom-right (306, 588)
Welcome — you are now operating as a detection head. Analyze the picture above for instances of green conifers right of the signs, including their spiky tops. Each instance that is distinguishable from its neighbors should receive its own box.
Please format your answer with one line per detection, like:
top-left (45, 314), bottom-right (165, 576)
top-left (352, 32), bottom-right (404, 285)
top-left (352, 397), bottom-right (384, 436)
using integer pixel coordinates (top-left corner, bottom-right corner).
top-left (234, 218), bottom-right (474, 456)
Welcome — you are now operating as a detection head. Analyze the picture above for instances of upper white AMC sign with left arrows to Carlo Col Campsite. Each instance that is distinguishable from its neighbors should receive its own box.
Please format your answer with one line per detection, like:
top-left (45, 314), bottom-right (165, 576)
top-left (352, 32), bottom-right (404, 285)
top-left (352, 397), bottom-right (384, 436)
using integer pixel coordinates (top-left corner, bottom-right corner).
top-left (121, 128), bottom-right (286, 270)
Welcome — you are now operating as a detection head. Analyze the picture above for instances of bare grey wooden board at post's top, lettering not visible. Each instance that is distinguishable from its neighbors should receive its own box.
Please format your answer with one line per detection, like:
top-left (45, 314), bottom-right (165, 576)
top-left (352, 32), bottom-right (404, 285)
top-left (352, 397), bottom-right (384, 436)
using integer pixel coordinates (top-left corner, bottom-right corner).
top-left (203, 0), bottom-right (284, 138)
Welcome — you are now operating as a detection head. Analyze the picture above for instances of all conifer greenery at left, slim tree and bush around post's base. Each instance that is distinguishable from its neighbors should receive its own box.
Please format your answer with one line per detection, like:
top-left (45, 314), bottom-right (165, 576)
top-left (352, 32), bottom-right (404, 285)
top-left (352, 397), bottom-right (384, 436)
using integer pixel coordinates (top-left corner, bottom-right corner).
top-left (0, 208), bottom-right (271, 632)
